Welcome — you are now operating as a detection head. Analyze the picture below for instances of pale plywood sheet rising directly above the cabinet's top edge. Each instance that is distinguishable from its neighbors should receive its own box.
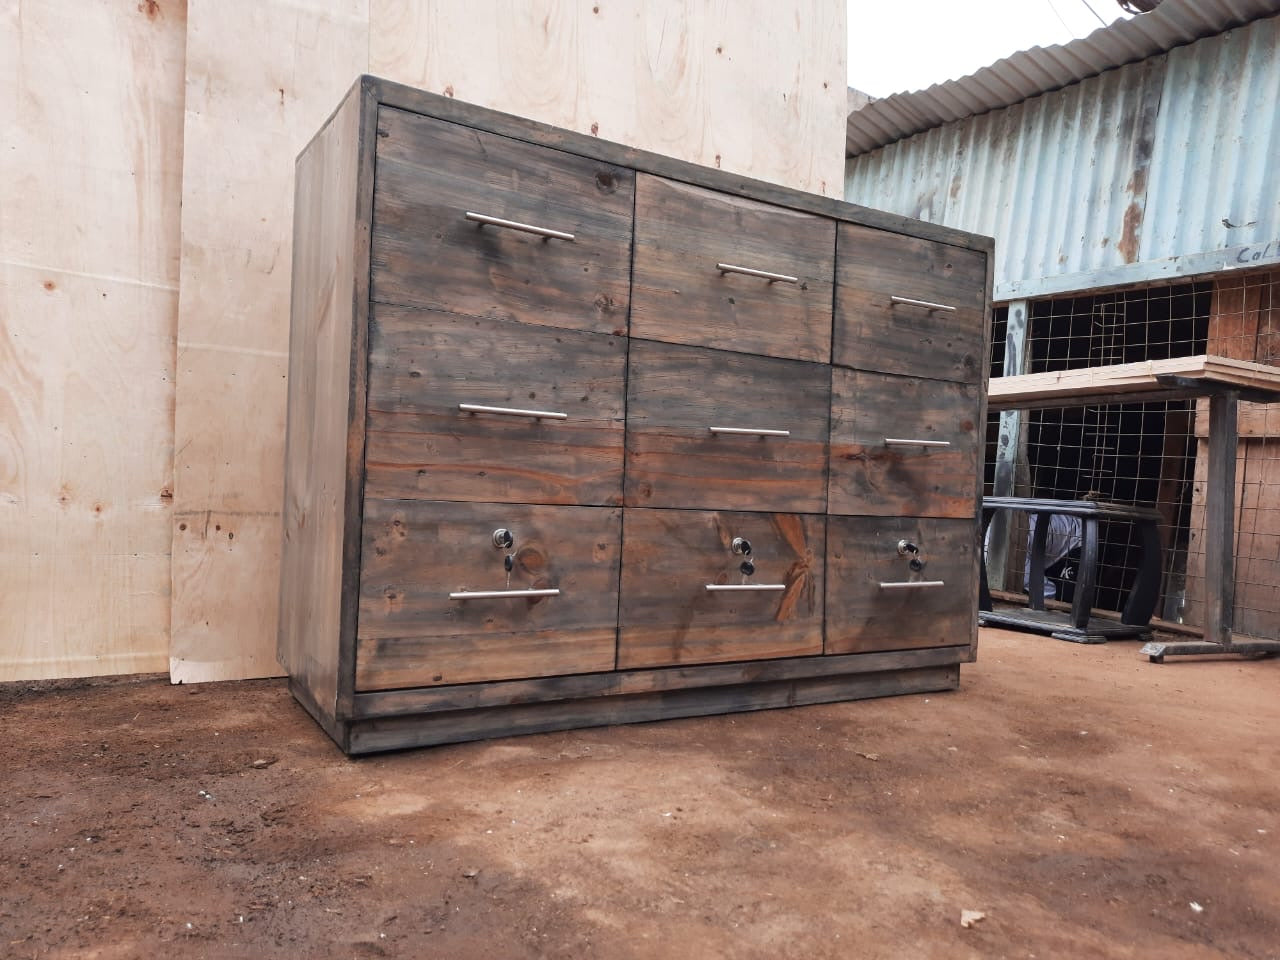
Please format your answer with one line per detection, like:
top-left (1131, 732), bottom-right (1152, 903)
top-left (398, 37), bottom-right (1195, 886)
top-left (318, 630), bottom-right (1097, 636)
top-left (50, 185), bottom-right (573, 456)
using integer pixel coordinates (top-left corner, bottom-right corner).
top-left (369, 0), bottom-right (846, 197)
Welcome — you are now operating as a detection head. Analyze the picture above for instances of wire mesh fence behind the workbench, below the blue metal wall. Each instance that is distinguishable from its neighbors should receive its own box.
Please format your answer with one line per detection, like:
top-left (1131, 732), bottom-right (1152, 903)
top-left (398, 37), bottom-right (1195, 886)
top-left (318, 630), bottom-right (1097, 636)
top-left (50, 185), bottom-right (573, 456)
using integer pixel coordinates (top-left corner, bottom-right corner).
top-left (984, 271), bottom-right (1280, 637)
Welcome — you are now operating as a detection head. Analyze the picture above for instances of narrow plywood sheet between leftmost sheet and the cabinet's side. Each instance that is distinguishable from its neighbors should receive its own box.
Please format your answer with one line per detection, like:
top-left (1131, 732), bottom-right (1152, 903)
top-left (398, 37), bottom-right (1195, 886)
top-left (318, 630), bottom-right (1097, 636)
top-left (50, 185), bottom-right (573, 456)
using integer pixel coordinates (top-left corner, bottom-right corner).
top-left (170, 0), bottom-right (369, 682)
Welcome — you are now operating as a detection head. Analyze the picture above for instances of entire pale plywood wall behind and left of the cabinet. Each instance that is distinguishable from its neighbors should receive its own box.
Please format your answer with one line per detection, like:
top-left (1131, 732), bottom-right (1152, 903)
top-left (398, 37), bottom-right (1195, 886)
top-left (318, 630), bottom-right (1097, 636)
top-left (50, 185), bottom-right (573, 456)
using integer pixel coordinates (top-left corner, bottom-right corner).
top-left (0, 0), bottom-right (845, 681)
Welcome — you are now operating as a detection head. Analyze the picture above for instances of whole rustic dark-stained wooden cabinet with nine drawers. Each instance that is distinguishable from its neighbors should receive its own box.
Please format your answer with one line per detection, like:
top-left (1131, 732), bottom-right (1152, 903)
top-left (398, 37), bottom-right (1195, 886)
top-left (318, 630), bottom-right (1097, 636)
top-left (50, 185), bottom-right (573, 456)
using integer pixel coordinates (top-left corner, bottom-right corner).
top-left (279, 77), bottom-right (991, 753)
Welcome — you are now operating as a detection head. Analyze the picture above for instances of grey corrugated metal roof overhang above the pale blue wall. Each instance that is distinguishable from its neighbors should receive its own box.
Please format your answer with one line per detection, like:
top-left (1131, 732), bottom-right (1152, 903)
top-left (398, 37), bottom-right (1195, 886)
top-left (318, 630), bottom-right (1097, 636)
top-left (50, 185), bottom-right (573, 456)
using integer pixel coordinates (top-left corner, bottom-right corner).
top-left (845, 0), bottom-right (1280, 156)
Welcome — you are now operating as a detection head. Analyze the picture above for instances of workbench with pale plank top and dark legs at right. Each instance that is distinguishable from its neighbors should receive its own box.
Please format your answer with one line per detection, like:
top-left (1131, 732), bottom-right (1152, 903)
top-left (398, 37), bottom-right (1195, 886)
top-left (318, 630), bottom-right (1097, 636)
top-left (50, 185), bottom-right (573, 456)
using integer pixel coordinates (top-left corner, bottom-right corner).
top-left (987, 355), bottom-right (1280, 663)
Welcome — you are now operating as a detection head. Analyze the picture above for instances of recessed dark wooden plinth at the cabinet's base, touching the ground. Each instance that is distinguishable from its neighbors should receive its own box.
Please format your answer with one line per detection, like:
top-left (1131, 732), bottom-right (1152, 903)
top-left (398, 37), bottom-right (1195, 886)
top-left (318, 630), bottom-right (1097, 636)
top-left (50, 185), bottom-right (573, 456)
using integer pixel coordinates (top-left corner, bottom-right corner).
top-left (344, 664), bottom-right (960, 754)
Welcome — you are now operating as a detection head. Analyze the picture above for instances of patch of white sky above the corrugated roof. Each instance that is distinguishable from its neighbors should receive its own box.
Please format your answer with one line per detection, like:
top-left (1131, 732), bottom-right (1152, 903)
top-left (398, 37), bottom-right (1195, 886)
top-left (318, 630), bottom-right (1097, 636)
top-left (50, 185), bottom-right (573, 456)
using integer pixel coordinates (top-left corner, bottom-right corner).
top-left (849, 0), bottom-right (1130, 97)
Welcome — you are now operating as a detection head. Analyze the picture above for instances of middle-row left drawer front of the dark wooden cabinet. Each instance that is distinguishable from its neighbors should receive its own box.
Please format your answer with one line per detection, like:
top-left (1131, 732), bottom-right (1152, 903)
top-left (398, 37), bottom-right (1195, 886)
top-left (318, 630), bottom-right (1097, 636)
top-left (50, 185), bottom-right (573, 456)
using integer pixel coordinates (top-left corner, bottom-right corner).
top-left (365, 305), bottom-right (626, 504)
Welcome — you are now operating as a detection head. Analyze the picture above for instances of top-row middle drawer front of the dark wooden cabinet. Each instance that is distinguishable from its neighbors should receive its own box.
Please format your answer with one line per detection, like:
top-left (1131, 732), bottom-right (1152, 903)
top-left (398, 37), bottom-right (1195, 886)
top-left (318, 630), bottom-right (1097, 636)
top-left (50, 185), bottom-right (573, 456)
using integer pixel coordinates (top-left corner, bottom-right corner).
top-left (631, 174), bottom-right (836, 362)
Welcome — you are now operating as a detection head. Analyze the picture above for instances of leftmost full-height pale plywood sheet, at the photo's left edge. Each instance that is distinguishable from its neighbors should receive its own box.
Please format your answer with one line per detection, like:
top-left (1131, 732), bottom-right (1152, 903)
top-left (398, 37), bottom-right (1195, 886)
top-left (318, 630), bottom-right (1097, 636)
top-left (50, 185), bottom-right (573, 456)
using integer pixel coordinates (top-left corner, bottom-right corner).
top-left (0, 0), bottom-right (186, 681)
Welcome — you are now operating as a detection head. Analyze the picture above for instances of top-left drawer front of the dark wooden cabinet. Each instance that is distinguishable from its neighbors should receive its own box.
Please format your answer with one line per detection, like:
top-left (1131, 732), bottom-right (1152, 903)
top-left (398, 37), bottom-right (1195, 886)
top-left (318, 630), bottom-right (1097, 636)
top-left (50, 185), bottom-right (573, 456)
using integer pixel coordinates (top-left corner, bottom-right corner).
top-left (372, 108), bottom-right (635, 334)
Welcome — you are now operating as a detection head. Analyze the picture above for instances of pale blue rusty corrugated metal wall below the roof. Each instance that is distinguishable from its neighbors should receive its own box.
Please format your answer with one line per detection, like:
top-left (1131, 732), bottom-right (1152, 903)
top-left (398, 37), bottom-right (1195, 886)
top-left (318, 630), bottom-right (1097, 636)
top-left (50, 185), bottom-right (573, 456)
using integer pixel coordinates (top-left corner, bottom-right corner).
top-left (845, 18), bottom-right (1280, 300)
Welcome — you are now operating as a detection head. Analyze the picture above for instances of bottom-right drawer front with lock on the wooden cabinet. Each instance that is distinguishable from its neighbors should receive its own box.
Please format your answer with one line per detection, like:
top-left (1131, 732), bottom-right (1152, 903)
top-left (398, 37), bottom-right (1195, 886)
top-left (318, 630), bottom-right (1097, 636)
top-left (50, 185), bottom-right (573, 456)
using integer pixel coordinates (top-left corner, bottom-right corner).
top-left (827, 517), bottom-right (978, 653)
